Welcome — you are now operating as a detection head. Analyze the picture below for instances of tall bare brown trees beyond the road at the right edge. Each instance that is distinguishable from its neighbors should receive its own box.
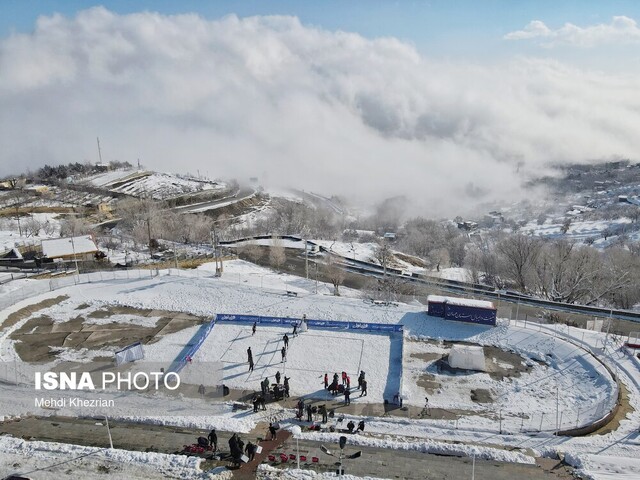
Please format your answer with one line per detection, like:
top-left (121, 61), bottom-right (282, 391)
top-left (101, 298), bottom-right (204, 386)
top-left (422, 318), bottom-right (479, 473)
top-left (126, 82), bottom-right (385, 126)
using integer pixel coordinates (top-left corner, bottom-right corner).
top-left (465, 234), bottom-right (640, 308)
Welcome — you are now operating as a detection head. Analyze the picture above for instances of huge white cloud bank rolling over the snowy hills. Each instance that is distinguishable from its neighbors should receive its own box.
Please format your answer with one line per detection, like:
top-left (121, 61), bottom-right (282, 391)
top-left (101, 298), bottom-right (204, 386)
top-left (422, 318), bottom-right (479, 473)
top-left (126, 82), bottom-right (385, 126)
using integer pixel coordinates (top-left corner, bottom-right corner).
top-left (0, 7), bottom-right (640, 216)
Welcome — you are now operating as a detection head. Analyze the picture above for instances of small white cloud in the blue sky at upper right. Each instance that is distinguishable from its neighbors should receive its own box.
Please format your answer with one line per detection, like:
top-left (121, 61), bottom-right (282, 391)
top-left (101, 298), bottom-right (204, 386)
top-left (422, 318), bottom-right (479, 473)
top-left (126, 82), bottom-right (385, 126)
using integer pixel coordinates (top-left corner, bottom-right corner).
top-left (504, 16), bottom-right (640, 47)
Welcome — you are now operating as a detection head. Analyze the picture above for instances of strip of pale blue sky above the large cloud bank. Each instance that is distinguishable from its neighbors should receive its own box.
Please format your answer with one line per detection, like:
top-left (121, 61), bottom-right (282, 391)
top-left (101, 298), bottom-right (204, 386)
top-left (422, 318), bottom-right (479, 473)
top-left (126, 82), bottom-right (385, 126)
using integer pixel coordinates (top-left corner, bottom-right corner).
top-left (5, 0), bottom-right (640, 57)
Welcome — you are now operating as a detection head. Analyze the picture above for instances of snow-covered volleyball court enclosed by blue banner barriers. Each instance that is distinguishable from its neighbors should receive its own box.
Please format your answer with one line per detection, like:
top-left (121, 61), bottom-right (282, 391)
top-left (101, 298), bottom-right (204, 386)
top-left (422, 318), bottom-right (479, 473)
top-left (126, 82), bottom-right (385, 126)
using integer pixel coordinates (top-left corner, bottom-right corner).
top-left (193, 324), bottom-right (401, 403)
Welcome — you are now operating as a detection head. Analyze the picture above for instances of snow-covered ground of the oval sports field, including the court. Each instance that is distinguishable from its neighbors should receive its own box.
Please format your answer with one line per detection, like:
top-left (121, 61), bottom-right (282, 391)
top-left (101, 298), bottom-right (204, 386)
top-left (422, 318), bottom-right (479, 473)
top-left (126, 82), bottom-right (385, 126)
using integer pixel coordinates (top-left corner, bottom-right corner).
top-left (0, 261), bottom-right (640, 479)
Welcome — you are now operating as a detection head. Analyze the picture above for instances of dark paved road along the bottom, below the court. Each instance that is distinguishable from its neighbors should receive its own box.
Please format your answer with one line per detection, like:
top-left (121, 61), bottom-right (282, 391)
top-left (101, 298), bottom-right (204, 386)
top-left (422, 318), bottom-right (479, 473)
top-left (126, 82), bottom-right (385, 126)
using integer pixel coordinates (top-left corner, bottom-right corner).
top-left (0, 417), bottom-right (573, 480)
